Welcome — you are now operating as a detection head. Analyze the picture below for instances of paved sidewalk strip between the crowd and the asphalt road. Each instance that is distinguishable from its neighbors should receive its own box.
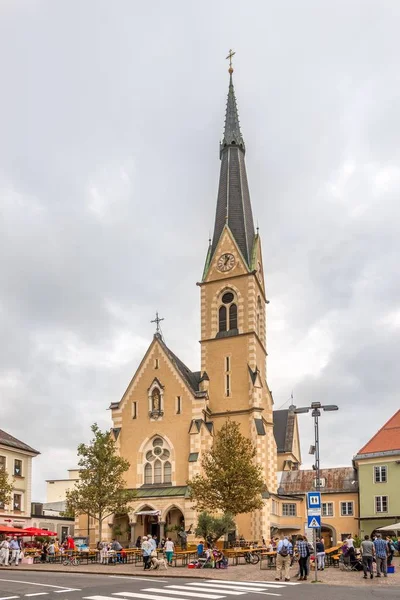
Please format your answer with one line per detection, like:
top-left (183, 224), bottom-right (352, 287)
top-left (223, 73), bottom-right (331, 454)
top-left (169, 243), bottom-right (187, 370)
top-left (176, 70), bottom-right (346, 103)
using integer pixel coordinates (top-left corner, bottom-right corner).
top-left (0, 558), bottom-right (400, 589)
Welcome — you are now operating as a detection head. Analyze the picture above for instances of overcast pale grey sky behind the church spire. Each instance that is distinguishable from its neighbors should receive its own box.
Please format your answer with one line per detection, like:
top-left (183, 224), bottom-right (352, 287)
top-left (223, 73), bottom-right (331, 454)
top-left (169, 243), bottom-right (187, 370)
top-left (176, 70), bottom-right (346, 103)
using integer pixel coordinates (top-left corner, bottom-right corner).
top-left (0, 0), bottom-right (400, 501)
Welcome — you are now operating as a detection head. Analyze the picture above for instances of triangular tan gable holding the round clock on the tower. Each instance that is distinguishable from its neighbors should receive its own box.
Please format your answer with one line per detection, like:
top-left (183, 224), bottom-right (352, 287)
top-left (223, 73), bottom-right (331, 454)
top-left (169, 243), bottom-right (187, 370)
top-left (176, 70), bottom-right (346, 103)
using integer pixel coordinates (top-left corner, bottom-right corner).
top-left (203, 225), bottom-right (249, 282)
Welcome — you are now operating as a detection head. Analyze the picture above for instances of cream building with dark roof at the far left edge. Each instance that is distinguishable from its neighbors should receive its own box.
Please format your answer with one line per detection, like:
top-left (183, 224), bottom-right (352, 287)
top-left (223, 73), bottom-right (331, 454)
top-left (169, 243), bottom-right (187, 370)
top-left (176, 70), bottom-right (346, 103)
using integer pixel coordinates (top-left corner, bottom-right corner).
top-left (0, 429), bottom-right (39, 527)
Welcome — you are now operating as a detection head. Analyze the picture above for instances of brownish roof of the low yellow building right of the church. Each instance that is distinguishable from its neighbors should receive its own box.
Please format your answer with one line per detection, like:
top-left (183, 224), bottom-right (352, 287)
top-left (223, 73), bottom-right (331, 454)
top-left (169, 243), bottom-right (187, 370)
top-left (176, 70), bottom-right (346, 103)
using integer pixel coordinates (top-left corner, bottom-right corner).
top-left (279, 467), bottom-right (358, 494)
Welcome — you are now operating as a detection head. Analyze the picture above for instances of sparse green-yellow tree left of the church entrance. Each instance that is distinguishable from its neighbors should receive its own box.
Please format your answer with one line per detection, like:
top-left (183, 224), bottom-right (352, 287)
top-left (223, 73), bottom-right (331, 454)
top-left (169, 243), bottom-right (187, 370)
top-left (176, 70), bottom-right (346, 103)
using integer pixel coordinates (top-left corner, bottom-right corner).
top-left (66, 423), bottom-right (135, 537)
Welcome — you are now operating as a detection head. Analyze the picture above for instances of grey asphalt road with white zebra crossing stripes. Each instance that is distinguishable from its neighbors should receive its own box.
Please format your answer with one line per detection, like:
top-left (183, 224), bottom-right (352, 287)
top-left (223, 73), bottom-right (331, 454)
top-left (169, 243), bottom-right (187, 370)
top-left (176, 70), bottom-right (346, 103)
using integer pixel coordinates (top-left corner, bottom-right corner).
top-left (0, 569), bottom-right (400, 600)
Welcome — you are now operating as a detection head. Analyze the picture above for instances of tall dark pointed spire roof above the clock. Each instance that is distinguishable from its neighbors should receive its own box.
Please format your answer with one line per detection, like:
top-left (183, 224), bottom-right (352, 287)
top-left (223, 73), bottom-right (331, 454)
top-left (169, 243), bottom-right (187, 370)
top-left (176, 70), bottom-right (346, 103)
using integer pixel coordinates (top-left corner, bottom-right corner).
top-left (209, 74), bottom-right (254, 267)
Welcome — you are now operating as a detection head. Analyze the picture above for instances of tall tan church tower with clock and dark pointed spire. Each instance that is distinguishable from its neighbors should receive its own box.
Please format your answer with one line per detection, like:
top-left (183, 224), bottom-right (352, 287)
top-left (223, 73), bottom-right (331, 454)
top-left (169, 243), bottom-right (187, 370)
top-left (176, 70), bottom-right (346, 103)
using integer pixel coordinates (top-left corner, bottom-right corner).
top-left (199, 61), bottom-right (277, 539)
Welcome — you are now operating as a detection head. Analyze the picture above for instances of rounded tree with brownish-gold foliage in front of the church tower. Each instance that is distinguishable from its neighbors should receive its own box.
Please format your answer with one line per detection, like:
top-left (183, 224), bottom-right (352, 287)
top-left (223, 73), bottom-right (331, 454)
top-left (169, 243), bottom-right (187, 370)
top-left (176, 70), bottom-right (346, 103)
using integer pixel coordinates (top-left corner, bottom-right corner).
top-left (188, 420), bottom-right (265, 516)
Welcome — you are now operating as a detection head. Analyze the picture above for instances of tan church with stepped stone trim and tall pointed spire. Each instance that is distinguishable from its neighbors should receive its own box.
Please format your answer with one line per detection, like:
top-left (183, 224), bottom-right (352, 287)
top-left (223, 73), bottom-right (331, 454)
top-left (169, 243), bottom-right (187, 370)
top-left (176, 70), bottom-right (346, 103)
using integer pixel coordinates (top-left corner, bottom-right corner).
top-left (82, 65), bottom-right (301, 543)
